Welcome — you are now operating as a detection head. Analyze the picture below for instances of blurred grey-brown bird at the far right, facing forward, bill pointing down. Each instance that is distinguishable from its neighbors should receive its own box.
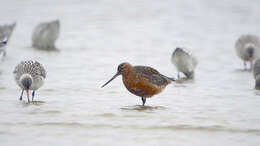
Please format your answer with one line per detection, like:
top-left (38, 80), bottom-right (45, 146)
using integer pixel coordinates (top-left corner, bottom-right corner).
top-left (235, 34), bottom-right (260, 70)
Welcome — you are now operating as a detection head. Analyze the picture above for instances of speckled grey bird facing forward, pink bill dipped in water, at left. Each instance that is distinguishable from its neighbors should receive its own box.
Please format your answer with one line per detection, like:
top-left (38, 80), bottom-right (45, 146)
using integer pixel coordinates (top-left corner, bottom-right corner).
top-left (13, 60), bottom-right (46, 103)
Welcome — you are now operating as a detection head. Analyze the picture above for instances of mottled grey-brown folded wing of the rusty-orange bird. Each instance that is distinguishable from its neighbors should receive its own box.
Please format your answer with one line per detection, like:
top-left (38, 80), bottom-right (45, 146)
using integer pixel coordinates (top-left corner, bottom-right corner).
top-left (134, 66), bottom-right (171, 86)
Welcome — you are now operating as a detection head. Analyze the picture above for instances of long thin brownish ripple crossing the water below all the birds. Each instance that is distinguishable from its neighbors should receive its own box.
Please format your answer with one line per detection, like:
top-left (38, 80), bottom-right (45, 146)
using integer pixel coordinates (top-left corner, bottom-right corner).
top-left (0, 122), bottom-right (260, 135)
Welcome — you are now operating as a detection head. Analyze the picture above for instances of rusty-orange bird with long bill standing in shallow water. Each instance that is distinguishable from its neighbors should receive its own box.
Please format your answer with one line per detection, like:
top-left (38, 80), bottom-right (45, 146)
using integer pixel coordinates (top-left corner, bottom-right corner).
top-left (102, 63), bottom-right (174, 106)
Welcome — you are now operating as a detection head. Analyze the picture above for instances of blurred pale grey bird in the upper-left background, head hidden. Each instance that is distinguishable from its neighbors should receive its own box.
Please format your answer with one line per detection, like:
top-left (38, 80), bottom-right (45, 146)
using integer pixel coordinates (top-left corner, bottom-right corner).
top-left (32, 20), bottom-right (60, 50)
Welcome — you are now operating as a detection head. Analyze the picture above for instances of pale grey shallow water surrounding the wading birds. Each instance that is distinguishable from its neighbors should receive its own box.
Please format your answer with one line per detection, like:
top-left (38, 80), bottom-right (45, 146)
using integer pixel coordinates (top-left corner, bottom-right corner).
top-left (0, 0), bottom-right (260, 146)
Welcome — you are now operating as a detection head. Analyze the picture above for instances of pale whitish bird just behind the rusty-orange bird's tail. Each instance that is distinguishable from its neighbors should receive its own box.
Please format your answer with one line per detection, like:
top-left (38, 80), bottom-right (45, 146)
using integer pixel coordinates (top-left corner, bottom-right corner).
top-left (171, 47), bottom-right (198, 78)
